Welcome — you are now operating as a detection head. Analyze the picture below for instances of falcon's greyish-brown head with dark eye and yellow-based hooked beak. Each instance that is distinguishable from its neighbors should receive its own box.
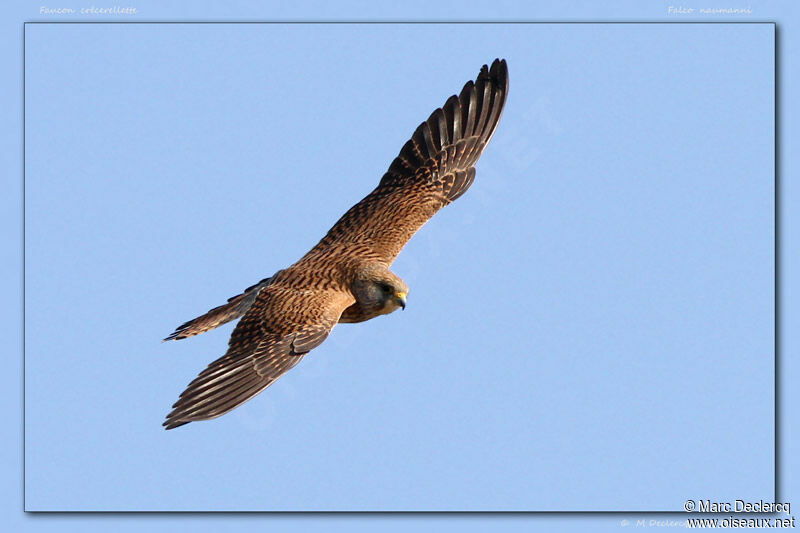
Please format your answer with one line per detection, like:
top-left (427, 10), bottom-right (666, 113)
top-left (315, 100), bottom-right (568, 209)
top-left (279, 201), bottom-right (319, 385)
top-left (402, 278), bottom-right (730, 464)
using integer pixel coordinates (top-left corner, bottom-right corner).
top-left (352, 264), bottom-right (408, 315)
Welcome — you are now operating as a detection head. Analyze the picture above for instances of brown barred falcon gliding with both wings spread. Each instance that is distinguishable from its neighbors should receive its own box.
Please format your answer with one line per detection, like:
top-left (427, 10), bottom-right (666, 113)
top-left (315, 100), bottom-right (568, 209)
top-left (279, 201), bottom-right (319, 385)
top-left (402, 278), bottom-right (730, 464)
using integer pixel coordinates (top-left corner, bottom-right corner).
top-left (163, 59), bottom-right (508, 429)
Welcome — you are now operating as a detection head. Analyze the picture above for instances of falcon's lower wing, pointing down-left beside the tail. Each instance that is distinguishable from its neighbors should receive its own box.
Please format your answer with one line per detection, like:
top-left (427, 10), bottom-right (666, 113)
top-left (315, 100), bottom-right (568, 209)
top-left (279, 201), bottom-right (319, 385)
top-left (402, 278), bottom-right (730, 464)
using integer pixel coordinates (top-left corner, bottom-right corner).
top-left (164, 286), bottom-right (352, 429)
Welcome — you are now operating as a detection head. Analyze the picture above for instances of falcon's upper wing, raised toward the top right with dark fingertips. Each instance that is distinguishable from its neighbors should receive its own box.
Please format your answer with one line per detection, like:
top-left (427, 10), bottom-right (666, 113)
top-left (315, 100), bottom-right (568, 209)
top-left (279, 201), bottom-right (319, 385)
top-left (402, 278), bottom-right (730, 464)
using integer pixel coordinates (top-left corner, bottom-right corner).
top-left (312, 59), bottom-right (508, 263)
